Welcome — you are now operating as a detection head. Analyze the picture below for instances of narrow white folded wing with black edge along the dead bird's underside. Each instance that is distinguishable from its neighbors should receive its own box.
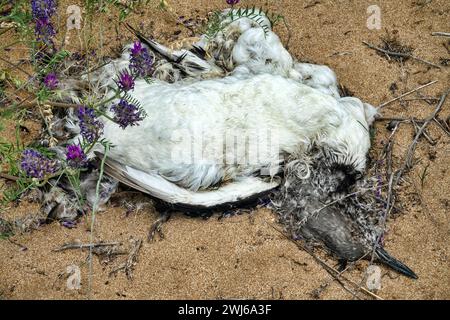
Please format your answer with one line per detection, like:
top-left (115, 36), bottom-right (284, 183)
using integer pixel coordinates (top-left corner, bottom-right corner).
top-left (95, 152), bottom-right (280, 210)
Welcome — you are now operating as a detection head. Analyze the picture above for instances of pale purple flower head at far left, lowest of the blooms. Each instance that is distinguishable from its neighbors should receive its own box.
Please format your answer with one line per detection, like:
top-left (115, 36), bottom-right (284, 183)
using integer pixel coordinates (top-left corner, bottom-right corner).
top-left (20, 149), bottom-right (59, 179)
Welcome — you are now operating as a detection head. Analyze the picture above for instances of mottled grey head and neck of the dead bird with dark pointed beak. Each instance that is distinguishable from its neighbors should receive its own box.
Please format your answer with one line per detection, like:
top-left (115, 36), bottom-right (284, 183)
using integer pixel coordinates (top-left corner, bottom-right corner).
top-left (273, 151), bottom-right (417, 279)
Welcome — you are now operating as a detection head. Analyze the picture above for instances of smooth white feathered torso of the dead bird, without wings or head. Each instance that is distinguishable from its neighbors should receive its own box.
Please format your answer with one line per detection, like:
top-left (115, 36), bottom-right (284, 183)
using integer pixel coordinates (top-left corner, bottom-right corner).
top-left (99, 73), bottom-right (370, 190)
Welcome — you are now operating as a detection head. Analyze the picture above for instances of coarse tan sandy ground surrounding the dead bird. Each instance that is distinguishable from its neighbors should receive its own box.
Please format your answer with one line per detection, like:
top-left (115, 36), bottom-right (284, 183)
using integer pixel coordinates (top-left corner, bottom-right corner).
top-left (0, 0), bottom-right (450, 299)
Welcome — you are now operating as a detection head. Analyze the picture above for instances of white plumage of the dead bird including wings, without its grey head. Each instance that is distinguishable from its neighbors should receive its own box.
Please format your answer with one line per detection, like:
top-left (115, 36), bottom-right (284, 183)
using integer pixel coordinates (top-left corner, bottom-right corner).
top-left (61, 8), bottom-right (376, 207)
